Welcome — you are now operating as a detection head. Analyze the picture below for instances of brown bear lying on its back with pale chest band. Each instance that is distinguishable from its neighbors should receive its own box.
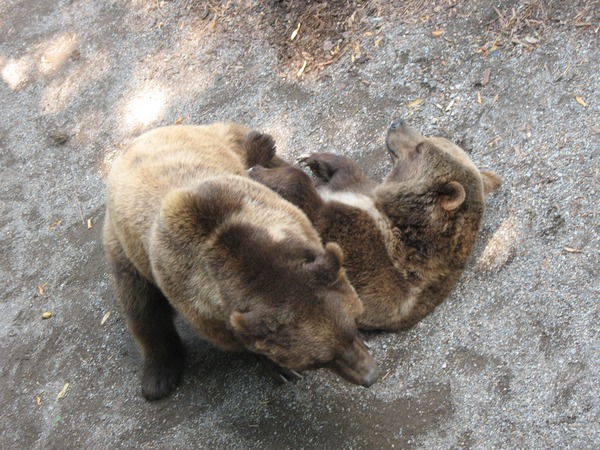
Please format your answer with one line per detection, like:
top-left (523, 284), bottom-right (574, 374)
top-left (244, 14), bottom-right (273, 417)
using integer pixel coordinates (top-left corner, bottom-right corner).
top-left (249, 120), bottom-right (501, 330)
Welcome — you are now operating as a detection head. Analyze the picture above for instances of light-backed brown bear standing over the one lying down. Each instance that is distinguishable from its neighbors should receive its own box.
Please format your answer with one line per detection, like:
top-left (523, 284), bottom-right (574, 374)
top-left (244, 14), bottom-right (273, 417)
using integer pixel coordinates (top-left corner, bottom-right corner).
top-left (104, 124), bottom-right (379, 400)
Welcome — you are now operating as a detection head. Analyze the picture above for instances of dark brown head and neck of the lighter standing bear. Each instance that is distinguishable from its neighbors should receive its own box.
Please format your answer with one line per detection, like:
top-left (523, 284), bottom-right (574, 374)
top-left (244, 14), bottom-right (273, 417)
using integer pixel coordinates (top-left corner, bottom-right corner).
top-left (211, 224), bottom-right (379, 386)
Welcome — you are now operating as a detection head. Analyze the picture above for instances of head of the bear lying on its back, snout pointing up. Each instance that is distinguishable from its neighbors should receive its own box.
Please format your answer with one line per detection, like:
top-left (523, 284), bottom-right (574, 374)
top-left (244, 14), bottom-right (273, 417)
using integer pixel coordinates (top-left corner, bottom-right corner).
top-left (375, 119), bottom-right (501, 248)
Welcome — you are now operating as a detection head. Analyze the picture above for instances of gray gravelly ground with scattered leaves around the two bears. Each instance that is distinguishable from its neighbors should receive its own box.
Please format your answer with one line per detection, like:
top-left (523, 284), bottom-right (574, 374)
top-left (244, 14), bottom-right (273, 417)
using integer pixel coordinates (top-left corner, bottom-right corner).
top-left (0, 0), bottom-right (600, 449)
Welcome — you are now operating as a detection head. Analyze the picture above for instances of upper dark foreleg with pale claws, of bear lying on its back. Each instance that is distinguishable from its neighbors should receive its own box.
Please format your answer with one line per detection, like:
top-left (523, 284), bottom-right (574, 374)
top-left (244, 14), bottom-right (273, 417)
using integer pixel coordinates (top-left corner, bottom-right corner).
top-left (298, 153), bottom-right (370, 191)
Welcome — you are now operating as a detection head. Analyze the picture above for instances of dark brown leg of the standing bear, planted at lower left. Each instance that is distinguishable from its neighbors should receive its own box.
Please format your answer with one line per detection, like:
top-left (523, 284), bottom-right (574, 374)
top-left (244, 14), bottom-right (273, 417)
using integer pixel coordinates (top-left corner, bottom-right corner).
top-left (112, 255), bottom-right (185, 400)
